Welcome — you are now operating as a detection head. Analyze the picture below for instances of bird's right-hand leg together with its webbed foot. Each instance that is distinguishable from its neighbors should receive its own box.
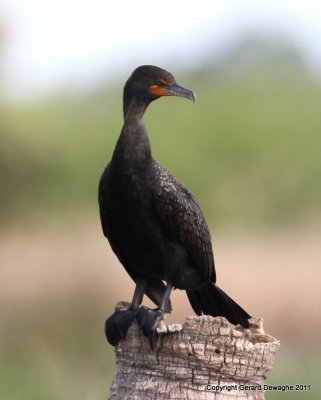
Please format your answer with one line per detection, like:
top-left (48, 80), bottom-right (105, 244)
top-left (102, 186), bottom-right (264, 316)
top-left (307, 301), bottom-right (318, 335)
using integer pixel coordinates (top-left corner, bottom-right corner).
top-left (137, 282), bottom-right (173, 350)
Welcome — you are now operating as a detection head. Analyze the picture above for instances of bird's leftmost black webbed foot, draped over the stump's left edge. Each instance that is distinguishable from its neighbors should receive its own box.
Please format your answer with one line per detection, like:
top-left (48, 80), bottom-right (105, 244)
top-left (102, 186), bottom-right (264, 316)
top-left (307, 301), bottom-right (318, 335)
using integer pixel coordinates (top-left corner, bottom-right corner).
top-left (105, 308), bottom-right (137, 346)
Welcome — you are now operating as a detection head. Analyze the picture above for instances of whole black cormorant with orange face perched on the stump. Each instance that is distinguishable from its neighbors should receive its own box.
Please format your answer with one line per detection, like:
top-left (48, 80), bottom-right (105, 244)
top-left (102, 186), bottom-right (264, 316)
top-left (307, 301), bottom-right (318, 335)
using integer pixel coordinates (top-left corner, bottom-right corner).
top-left (99, 65), bottom-right (251, 346)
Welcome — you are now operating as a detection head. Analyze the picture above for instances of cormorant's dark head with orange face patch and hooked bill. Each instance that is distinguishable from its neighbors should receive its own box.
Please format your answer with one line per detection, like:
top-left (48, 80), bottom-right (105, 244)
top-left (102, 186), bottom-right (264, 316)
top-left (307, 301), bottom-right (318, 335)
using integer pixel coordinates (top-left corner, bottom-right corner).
top-left (124, 65), bottom-right (195, 112)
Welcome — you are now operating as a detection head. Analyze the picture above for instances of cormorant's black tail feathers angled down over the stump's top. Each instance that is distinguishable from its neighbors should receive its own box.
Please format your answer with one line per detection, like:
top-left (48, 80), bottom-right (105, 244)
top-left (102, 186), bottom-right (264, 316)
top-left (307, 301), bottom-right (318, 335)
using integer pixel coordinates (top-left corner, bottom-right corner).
top-left (186, 282), bottom-right (251, 328)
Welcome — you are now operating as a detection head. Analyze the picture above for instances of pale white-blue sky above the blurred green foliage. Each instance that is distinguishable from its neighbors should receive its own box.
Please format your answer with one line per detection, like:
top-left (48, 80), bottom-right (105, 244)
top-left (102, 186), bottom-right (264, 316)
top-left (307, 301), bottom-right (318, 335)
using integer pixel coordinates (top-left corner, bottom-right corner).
top-left (0, 0), bottom-right (321, 98)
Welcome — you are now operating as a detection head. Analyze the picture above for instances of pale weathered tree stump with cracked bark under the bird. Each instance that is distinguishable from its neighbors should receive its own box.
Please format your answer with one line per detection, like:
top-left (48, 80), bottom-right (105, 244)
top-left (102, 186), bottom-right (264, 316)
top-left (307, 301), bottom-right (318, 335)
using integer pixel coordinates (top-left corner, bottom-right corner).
top-left (110, 302), bottom-right (280, 400)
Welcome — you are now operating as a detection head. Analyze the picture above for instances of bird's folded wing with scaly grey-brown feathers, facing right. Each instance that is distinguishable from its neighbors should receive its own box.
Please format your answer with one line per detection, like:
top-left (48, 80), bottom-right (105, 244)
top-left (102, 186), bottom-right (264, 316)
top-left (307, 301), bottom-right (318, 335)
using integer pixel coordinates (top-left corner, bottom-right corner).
top-left (153, 161), bottom-right (216, 282)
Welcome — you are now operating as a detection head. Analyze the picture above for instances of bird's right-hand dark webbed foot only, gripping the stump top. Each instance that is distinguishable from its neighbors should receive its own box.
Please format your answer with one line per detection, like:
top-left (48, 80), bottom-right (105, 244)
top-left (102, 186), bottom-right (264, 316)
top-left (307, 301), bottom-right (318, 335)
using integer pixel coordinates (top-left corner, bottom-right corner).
top-left (137, 307), bottom-right (165, 350)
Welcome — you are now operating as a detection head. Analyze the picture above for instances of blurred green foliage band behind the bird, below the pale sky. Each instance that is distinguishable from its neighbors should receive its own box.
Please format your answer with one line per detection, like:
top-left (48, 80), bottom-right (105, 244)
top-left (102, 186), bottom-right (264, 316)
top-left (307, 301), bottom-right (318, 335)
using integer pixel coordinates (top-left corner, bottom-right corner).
top-left (0, 37), bottom-right (321, 231)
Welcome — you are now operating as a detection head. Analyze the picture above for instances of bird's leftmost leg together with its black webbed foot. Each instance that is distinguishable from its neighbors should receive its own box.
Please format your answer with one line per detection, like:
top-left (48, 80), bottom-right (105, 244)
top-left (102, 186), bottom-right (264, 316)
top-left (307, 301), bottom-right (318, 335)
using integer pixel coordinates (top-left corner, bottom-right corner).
top-left (105, 279), bottom-right (148, 346)
